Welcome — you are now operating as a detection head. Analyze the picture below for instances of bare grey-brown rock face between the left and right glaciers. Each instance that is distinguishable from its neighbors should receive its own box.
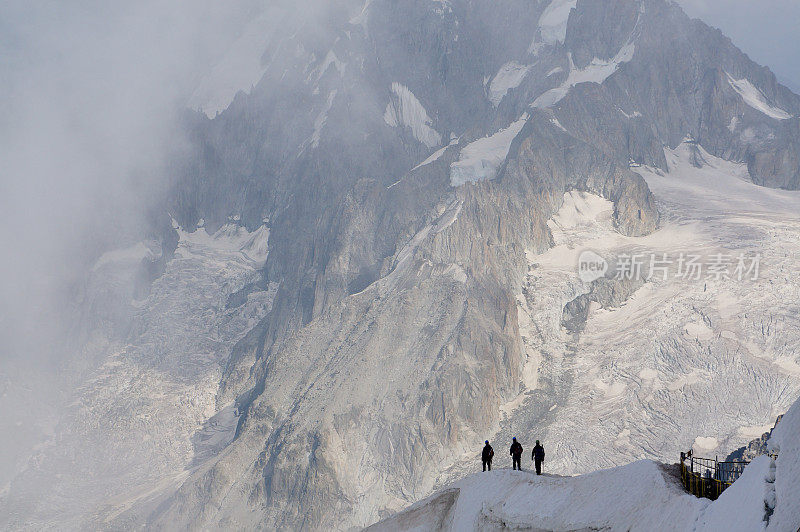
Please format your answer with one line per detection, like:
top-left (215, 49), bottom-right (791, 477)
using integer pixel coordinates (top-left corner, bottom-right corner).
top-left (6, 0), bottom-right (800, 529)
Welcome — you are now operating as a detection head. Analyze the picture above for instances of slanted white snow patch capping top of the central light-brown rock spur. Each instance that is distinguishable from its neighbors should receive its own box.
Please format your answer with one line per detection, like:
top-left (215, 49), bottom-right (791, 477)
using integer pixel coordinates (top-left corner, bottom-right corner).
top-left (450, 113), bottom-right (528, 187)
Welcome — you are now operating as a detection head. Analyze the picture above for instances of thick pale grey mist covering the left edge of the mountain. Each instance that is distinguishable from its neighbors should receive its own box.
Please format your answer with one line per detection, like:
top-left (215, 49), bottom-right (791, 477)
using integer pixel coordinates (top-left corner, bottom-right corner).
top-left (0, 0), bottom-right (265, 491)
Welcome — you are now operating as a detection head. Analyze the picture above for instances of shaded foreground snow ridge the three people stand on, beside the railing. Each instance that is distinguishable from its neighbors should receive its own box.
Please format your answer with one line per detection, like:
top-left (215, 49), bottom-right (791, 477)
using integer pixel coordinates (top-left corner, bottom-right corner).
top-left (367, 390), bottom-right (800, 532)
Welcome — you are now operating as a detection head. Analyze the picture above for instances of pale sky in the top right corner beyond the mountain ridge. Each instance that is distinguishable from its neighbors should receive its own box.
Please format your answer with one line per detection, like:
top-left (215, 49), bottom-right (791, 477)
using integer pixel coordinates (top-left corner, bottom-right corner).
top-left (677, 0), bottom-right (800, 93)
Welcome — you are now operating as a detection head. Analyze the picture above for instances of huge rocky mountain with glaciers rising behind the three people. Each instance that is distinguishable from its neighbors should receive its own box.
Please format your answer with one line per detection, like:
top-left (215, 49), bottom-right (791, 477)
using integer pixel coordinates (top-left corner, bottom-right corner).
top-left (0, 0), bottom-right (800, 529)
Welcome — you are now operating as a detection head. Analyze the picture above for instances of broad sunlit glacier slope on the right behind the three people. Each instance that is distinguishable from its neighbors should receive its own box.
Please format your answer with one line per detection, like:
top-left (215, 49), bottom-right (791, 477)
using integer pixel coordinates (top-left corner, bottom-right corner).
top-left (494, 140), bottom-right (800, 473)
